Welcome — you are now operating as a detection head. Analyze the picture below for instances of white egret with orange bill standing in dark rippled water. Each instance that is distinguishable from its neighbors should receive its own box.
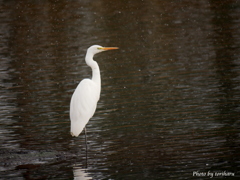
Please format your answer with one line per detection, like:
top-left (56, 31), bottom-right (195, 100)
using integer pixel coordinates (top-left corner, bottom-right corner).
top-left (70, 45), bottom-right (118, 138)
